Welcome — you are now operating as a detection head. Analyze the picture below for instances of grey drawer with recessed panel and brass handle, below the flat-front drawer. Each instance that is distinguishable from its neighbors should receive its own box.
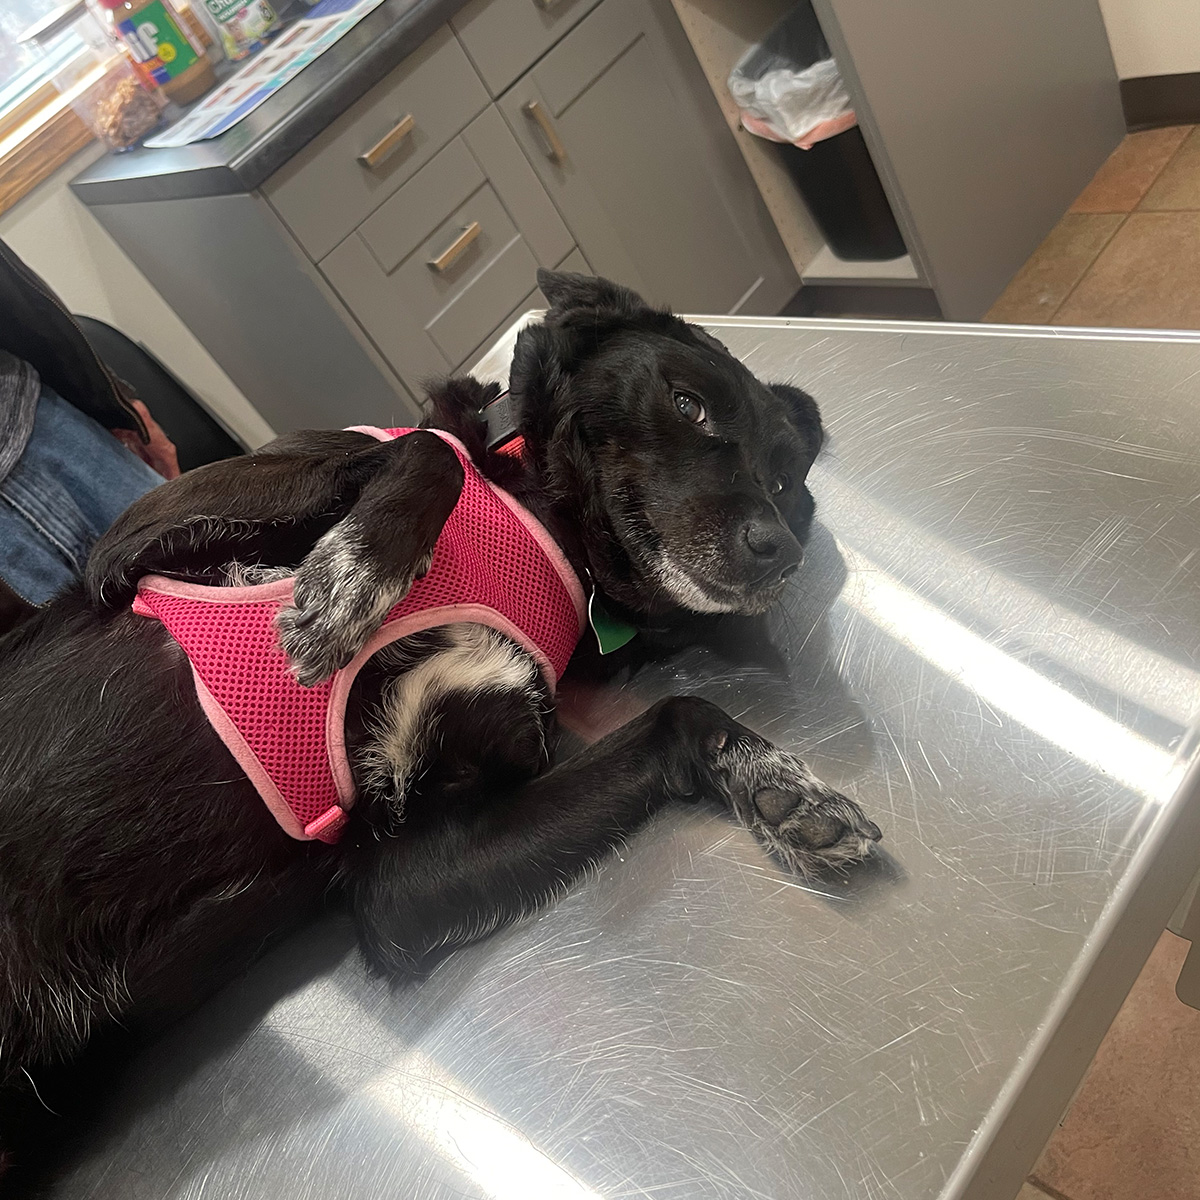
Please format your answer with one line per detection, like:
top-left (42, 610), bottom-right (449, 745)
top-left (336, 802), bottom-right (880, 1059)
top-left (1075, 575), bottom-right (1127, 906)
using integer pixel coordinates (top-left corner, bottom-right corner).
top-left (320, 154), bottom-right (538, 386)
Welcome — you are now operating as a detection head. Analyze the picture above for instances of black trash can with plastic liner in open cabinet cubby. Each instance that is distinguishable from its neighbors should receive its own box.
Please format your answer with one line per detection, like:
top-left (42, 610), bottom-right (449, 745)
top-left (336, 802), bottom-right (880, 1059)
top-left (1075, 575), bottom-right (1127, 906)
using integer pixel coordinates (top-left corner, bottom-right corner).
top-left (728, 0), bottom-right (905, 262)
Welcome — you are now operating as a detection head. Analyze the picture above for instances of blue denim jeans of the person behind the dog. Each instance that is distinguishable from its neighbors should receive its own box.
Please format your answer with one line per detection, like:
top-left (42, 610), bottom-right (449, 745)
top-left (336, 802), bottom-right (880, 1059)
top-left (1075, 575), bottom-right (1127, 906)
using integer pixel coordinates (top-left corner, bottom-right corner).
top-left (0, 385), bottom-right (162, 605)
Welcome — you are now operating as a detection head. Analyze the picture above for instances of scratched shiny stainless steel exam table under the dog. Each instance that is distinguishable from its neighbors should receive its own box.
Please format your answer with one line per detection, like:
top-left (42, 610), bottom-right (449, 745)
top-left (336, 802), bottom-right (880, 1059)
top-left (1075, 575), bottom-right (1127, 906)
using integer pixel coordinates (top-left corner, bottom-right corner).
top-left (51, 318), bottom-right (1200, 1200)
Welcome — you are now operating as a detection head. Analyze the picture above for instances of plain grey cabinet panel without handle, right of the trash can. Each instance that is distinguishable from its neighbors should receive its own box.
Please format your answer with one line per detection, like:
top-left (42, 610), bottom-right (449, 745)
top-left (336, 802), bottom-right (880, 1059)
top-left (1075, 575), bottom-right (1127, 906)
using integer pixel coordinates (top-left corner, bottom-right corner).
top-left (814, 0), bottom-right (1123, 320)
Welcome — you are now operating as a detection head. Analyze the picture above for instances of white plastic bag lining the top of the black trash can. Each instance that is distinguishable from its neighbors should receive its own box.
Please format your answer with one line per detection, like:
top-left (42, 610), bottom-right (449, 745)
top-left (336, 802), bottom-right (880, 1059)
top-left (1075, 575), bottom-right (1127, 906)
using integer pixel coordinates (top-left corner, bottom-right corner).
top-left (728, 4), bottom-right (856, 149)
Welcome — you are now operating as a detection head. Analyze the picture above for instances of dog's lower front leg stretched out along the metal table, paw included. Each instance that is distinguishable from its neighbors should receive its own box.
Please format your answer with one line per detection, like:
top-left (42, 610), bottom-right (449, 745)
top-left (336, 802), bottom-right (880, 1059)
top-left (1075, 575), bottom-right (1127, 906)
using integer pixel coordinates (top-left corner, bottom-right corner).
top-left (349, 697), bottom-right (880, 973)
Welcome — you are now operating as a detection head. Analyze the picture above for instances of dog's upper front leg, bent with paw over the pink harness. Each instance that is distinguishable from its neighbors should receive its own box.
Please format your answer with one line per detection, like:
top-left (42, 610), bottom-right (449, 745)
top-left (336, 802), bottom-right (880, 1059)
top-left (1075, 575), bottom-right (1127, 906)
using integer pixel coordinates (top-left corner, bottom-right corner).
top-left (88, 431), bottom-right (463, 684)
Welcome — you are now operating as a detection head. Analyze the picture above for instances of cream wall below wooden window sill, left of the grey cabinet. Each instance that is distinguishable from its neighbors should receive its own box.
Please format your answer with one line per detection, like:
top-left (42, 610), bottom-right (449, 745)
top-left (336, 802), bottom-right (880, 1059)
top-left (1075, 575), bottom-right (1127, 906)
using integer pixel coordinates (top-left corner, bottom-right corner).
top-left (0, 148), bottom-right (274, 446)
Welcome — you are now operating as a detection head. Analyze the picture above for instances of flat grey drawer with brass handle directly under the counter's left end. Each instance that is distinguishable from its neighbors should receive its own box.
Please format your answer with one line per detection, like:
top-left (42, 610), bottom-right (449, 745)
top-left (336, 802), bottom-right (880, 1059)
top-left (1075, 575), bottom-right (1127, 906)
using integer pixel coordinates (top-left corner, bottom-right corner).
top-left (263, 28), bottom-right (487, 260)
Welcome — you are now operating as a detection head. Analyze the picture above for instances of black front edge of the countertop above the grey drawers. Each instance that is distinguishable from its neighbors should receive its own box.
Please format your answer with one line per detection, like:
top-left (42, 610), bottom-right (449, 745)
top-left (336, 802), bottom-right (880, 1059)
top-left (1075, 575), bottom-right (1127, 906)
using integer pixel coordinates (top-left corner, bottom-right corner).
top-left (71, 0), bottom-right (467, 204)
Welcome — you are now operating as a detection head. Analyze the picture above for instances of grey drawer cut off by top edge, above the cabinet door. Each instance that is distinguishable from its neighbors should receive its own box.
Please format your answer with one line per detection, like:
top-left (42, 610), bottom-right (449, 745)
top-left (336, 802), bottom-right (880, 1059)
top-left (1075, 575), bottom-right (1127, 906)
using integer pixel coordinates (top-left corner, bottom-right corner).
top-left (450, 0), bottom-right (596, 96)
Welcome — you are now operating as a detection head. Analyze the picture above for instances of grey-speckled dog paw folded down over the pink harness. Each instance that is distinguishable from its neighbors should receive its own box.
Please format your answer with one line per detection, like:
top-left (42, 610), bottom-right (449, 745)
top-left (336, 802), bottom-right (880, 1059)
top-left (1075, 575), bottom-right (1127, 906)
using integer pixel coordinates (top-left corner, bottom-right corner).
top-left (275, 521), bottom-right (433, 688)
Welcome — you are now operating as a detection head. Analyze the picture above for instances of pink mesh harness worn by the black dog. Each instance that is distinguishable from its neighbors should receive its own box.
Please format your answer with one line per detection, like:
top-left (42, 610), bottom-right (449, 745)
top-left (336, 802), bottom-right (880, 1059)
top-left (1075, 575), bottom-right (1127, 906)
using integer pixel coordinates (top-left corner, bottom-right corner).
top-left (133, 426), bottom-right (584, 842)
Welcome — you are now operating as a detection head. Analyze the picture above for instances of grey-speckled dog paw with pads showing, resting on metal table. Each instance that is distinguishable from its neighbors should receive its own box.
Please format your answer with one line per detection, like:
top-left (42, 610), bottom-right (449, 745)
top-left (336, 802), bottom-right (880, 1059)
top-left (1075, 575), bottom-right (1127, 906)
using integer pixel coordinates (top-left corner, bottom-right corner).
top-left (715, 731), bottom-right (883, 875)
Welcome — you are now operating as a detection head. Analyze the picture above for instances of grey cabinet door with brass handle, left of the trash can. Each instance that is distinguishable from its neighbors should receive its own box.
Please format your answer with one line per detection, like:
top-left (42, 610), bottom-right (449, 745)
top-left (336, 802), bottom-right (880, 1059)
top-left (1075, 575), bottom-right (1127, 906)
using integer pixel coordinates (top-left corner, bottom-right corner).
top-left (500, 0), bottom-right (797, 313)
